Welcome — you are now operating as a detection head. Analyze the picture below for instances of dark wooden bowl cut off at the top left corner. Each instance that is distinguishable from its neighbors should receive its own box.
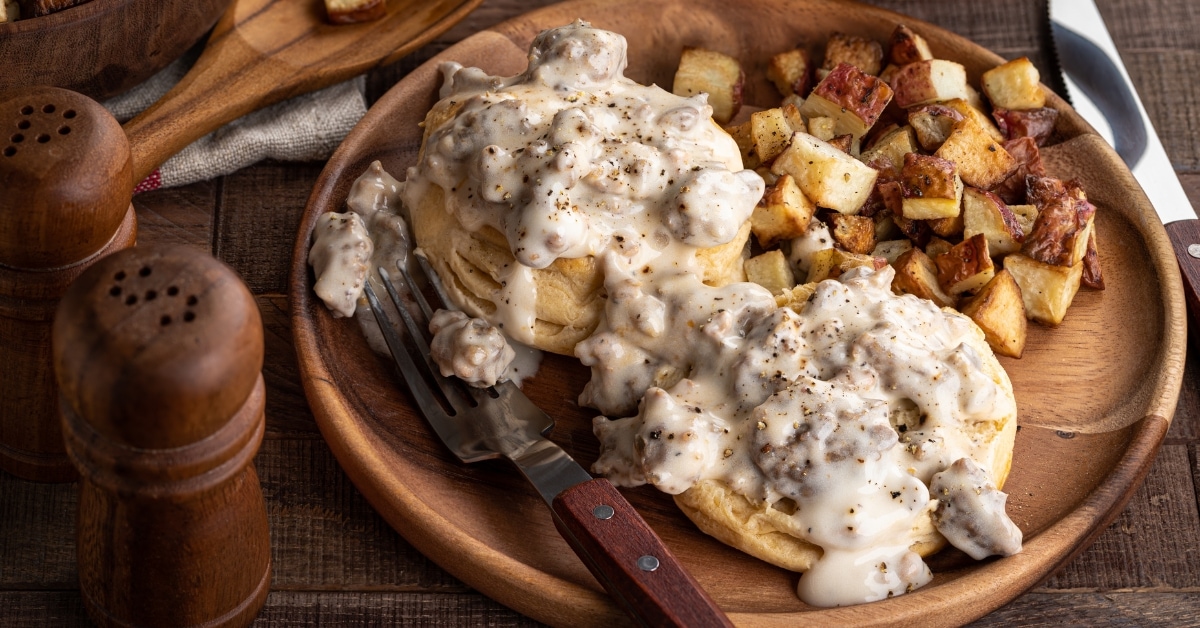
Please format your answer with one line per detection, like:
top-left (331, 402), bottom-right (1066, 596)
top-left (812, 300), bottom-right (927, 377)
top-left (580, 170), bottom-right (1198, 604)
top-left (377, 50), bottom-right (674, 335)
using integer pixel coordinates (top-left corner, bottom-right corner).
top-left (0, 0), bottom-right (230, 100)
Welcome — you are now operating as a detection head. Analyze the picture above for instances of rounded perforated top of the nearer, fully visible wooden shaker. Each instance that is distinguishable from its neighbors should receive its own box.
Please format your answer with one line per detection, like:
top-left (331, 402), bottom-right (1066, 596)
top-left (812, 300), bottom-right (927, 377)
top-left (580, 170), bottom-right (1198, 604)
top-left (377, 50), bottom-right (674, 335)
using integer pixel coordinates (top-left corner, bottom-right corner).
top-left (54, 245), bottom-right (263, 449)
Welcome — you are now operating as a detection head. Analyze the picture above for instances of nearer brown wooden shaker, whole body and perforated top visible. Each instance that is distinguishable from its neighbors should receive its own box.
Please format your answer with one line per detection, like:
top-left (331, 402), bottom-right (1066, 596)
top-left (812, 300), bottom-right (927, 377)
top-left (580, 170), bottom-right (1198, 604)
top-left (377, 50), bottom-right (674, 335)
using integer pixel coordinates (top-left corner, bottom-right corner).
top-left (54, 245), bottom-right (271, 627)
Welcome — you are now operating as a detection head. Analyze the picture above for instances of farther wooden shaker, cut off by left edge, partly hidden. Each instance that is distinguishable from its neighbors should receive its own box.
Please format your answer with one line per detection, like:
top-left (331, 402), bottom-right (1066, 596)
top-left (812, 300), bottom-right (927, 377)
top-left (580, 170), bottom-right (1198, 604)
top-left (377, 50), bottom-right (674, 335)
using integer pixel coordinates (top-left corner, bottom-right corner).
top-left (0, 86), bottom-right (137, 482)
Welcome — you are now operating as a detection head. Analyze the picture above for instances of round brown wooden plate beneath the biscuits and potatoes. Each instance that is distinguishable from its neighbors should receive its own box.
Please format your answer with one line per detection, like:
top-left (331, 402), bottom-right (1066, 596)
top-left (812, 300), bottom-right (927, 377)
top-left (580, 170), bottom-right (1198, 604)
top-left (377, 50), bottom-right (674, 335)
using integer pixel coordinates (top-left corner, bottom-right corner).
top-left (290, 0), bottom-right (1186, 626)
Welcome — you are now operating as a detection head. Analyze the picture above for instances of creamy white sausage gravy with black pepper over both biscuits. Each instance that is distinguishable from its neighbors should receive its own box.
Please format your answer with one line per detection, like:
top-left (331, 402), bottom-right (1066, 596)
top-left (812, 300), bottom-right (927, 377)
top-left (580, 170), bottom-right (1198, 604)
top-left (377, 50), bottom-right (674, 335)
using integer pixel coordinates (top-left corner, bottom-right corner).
top-left (310, 22), bottom-right (1021, 606)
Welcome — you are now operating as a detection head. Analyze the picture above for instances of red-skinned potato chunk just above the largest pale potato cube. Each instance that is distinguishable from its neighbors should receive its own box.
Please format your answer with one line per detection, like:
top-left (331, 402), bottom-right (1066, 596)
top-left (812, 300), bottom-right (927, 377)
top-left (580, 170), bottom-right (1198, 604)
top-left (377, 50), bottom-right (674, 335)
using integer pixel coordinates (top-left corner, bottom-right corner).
top-left (800, 64), bottom-right (892, 139)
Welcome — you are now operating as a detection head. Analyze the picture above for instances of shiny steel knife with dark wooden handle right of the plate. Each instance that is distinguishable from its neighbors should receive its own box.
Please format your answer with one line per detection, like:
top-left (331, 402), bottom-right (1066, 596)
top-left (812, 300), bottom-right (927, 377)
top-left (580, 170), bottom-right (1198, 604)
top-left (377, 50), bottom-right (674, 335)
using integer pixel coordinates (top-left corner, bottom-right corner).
top-left (1049, 0), bottom-right (1200, 317)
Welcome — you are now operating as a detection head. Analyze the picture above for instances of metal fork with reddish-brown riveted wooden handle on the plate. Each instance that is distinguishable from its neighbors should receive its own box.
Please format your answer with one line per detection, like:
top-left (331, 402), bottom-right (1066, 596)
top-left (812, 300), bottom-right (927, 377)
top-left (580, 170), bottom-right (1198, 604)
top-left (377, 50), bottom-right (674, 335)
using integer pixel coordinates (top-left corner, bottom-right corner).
top-left (366, 253), bottom-right (732, 627)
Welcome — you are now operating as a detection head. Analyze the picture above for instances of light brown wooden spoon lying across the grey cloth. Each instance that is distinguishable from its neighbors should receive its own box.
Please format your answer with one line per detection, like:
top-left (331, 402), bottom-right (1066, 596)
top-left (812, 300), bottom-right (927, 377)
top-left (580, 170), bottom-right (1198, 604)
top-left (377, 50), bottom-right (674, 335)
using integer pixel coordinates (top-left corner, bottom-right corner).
top-left (125, 0), bottom-right (482, 181)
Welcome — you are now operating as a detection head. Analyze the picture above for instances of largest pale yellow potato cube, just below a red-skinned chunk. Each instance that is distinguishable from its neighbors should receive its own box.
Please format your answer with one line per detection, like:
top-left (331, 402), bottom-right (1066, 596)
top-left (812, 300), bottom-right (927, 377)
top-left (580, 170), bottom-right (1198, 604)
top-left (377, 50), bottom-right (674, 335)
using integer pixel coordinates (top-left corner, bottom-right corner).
top-left (770, 133), bottom-right (878, 214)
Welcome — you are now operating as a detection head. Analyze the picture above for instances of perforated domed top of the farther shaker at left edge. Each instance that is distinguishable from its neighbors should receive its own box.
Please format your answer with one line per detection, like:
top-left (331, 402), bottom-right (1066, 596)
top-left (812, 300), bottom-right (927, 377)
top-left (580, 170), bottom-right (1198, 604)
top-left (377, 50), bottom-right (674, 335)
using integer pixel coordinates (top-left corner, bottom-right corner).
top-left (0, 86), bottom-right (133, 269)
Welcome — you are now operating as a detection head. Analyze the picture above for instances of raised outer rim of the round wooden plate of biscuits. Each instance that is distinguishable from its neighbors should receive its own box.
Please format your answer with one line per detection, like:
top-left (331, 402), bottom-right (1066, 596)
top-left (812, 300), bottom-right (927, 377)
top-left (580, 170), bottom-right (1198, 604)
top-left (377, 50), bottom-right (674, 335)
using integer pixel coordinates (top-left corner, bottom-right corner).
top-left (289, 0), bottom-right (1187, 624)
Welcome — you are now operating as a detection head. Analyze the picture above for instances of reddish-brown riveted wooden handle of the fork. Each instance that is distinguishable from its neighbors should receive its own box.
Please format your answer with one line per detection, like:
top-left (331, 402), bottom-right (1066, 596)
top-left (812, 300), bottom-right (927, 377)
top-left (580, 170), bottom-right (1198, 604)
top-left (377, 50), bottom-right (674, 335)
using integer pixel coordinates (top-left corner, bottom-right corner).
top-left (551, 478), bottom-right (733, 627)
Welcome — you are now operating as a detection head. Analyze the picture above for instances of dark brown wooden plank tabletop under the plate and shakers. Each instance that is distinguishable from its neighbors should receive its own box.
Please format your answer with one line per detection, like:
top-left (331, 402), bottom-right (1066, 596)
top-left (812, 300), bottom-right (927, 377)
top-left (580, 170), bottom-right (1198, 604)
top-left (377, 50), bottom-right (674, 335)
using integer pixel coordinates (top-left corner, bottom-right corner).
top-left (0, 0), bottom-right (1200, 627)
